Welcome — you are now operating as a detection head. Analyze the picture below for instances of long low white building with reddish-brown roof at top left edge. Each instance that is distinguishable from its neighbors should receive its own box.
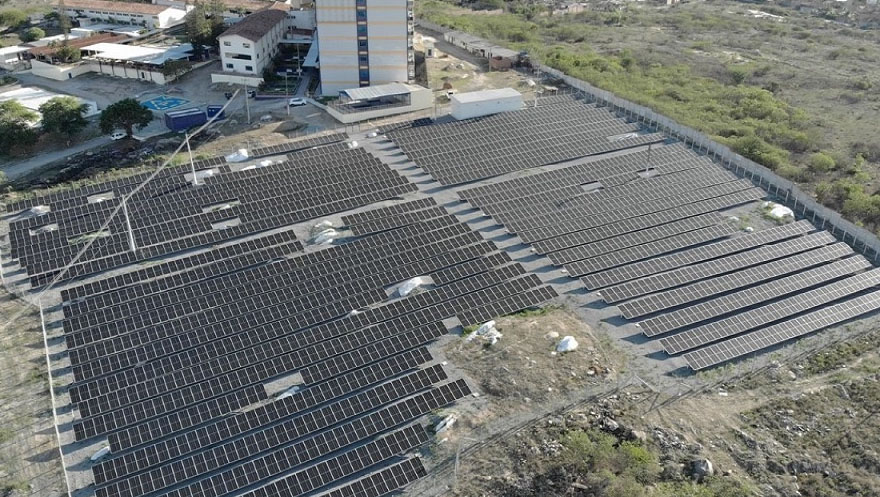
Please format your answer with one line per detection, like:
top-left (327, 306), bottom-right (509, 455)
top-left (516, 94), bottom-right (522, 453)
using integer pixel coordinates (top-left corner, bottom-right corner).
top-left (59, 0), bottom-right (186, 29)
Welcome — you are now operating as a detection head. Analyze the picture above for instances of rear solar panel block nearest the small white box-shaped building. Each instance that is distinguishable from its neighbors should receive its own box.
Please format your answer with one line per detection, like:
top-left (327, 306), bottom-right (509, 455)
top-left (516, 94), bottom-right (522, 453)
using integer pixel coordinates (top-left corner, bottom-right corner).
top-left (386, 97), bottom-right (664, 185)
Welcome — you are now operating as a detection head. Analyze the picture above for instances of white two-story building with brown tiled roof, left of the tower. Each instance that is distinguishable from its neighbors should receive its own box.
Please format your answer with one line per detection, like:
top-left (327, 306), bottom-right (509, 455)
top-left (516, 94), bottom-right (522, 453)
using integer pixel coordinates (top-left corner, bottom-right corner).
top-left (211, 4), bottom-right (288, 86)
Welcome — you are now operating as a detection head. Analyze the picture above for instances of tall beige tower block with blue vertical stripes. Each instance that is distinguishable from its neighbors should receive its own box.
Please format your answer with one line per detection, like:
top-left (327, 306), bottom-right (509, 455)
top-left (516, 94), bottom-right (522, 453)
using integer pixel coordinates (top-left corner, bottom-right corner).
top-left (315, 0), bottom-right (415, 95)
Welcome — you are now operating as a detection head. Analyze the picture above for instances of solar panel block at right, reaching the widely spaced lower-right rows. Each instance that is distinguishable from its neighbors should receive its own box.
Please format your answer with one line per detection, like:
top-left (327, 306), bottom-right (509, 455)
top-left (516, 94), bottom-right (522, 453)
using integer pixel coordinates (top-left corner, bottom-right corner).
top-left (446, 120), bottom-right (880, 369)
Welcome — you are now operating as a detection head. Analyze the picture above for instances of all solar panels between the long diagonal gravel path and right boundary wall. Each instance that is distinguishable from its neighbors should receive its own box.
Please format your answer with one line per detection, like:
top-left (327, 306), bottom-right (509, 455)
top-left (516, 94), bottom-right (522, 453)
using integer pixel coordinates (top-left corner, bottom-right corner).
top-left (376, 97), bottom-right (878, 369)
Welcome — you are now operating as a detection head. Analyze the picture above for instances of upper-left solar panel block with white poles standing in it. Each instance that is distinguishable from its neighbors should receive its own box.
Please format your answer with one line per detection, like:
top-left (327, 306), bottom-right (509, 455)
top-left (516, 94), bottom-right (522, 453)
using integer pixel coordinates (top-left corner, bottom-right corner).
top-left (9, 138), bottom-right (416, 286)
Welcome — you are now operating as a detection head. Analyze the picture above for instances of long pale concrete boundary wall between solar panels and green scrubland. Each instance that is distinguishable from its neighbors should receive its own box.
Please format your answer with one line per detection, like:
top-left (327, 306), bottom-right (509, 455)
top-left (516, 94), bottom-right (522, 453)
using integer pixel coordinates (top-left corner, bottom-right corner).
top-left (418, 20), bottom-right (880, 262)
